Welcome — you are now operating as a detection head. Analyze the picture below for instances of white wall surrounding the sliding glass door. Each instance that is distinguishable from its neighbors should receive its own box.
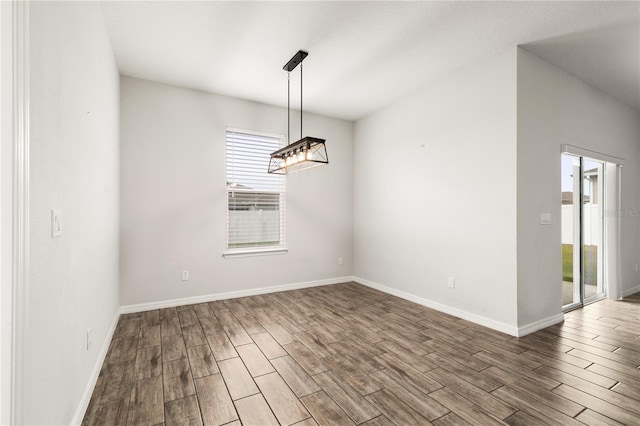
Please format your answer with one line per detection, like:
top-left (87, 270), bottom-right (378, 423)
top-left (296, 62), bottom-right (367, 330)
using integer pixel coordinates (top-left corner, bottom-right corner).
top-left (518, 49), bottom-right (640, 325)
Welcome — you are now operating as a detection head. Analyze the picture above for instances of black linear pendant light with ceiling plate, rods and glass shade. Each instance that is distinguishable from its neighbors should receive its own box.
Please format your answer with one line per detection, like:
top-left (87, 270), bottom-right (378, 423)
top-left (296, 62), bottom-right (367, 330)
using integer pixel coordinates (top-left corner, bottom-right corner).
top-left (268, 50), bottom-right (329, 175)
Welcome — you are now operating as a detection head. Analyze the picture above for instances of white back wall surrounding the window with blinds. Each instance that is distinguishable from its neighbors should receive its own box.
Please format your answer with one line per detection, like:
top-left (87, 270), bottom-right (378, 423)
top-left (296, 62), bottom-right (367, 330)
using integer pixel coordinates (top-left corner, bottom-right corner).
top-left (120, 75), bottom-right (353, 305)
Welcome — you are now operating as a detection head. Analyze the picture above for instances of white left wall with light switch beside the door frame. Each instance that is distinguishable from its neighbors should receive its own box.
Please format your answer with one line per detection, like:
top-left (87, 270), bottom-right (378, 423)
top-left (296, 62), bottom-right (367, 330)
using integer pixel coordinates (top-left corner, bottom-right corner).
top-left (24, 2), bottom-right (119, 424)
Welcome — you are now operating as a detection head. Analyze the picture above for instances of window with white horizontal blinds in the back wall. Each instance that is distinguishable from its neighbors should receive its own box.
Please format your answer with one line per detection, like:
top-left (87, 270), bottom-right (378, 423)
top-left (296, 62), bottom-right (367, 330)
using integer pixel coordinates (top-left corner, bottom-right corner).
top-left (225, 129), bottom-right (286, 256)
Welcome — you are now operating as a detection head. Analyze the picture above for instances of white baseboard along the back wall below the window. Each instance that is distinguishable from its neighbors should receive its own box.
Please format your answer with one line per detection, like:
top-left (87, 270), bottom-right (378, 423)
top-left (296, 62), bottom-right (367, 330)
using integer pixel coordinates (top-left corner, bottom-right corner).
top-left (120, 277), bottom-right (353, 314)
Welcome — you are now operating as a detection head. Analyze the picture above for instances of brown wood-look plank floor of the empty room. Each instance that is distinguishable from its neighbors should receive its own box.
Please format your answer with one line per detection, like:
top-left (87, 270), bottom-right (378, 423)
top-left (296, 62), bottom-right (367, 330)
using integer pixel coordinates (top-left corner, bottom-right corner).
top-left (83, 283), bottom-right (640, 426)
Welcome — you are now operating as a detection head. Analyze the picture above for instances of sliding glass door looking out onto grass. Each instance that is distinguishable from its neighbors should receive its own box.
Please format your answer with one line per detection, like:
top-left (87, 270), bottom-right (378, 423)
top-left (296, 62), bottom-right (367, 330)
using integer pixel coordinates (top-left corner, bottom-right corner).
top-left (561, 154), bottom-right (605, 310)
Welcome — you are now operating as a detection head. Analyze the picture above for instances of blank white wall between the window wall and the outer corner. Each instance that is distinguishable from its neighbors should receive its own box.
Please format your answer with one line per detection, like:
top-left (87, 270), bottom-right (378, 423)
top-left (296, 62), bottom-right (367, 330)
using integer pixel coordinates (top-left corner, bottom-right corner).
top-left (354, 48), bottom-right (517, 333)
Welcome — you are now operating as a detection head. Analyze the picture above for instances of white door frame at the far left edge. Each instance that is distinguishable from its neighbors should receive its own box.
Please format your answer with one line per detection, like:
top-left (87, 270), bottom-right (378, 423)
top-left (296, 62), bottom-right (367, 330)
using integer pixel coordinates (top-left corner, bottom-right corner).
top-left (0, 0), bottom-right (29, 424)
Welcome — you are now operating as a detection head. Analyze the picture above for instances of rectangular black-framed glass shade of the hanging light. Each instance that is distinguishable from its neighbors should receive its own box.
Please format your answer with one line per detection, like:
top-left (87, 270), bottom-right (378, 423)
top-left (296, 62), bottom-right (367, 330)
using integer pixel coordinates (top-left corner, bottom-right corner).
top-left (269, 136), bottom-right (329, 175)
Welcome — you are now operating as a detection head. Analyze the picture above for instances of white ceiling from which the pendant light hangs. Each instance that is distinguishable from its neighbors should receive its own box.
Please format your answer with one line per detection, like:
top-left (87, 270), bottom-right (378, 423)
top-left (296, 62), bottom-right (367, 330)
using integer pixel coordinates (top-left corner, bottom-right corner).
top-left (102, 1), bottom-right (640, 120)
